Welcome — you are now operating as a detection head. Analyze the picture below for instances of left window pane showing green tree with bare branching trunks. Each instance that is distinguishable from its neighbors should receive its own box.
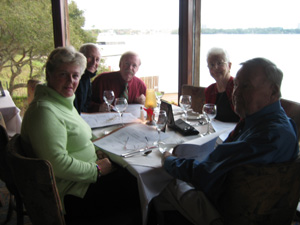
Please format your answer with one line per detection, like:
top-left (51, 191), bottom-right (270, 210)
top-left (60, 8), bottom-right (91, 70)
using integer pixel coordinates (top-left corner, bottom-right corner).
top-left (0, 0), bottom-right (54, 116)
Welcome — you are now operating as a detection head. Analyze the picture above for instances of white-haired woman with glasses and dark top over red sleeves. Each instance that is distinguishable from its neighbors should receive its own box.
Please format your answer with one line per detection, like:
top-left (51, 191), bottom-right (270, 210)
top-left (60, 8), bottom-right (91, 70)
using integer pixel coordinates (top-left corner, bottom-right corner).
top-left (204, 48), bottom-right (239, 122)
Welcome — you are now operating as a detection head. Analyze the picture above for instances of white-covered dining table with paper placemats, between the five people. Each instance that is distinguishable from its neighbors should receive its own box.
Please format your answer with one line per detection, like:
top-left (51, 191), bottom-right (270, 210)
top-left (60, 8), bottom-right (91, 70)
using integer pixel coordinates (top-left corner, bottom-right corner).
top-left (82, 104), bottom-right (235, 225)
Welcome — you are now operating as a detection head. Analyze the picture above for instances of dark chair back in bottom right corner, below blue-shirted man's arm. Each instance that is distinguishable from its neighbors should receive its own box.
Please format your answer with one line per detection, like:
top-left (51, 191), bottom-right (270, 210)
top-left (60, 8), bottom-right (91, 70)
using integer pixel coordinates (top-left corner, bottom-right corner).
top-left (217, 159), bottom-right (300, 225)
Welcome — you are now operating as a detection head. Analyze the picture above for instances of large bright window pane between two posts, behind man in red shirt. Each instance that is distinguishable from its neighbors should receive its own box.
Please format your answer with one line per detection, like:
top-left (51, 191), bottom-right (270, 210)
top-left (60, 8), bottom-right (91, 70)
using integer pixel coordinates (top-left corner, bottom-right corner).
top-left (69, 0), bottom-right (179, 101)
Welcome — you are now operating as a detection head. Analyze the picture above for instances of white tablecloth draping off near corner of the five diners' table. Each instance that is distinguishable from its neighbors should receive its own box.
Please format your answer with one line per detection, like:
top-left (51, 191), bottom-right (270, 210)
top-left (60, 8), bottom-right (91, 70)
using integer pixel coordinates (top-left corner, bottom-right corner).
top-left (93, 107), bottom-right (236, 224)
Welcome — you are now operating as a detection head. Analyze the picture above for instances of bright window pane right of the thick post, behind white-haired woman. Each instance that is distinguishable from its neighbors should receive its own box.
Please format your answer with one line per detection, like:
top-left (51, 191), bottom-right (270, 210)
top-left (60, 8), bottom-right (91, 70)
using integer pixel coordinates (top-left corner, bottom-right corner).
top-left (200, 0), bottom-right (300, 102)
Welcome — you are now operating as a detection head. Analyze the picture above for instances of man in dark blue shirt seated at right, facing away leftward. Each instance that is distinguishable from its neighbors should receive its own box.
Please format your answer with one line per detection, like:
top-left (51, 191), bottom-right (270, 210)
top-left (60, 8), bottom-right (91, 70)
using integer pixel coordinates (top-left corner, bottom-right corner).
top-left (156, 58), bottom-right (299, 225)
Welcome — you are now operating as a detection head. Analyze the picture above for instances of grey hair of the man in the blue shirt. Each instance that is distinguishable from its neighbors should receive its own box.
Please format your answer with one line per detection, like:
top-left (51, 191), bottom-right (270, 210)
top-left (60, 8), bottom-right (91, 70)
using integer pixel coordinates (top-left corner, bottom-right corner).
top-left (241, 58), bottom-right (283, 97)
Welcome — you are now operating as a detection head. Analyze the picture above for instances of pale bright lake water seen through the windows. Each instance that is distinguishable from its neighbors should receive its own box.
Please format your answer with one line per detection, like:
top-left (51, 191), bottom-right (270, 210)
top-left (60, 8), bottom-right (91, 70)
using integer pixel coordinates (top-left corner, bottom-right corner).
top-left (98, 34), bottom-right (300, 102)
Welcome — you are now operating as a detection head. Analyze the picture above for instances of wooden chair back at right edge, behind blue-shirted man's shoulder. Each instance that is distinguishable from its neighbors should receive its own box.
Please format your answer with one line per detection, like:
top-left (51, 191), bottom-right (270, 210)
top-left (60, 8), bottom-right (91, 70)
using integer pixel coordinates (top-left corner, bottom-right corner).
top-left (280, 98), bottom-right (300, 141)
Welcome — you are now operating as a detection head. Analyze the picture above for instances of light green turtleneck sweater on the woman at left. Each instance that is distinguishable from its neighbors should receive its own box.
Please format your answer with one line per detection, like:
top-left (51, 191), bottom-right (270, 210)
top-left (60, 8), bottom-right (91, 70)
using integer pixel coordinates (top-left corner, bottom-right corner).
top-left (21, 85), bottom-right (97, 211)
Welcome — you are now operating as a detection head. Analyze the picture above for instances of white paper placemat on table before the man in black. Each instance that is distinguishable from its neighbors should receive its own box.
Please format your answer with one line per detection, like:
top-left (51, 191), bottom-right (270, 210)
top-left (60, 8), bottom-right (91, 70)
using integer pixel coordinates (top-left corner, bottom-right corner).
top-left (81, 112), bottom-right (140, 128)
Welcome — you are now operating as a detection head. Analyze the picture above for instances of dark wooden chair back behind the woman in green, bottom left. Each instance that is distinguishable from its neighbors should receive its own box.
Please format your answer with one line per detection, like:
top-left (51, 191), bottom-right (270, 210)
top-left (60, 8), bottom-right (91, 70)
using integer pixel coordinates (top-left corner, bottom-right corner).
top-left (6, 134), bottom-right (65, 225)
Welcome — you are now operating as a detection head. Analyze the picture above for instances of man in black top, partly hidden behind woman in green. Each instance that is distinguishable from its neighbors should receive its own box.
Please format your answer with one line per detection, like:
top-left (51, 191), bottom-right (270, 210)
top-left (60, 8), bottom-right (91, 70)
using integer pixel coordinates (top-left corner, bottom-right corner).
top-left (74, 43), bottom-right (101, 114)
